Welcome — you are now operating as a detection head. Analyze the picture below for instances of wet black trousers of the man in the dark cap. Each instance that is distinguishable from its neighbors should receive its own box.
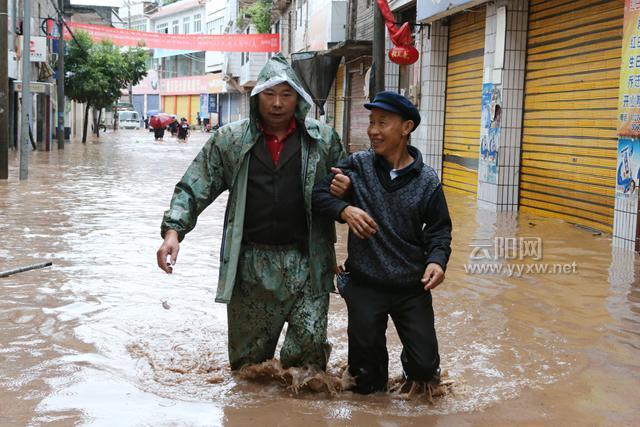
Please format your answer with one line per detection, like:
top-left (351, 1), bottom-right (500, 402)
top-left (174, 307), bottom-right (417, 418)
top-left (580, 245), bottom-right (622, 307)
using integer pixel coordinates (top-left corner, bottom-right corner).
top-left (342, 280), bottom-right (440, 394)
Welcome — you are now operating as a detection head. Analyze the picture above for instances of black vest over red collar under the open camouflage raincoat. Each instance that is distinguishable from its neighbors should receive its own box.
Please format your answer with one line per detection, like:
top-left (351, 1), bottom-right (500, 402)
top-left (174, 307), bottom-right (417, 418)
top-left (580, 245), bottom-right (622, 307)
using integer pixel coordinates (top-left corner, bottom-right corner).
top-left (243, 130), bottom-right (307, 245)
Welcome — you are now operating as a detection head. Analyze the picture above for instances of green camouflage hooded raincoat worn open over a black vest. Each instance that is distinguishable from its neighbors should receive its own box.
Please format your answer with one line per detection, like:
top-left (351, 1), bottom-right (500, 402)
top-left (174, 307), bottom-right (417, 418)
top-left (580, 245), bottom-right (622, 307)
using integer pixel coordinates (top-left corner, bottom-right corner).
top-left (161, 54), bottom-right (345, 303)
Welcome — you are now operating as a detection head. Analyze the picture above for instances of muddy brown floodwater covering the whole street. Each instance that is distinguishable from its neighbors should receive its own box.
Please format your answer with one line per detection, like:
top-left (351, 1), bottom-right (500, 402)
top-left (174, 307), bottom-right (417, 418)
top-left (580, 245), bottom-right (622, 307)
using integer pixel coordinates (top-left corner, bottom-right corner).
top-left (0, 131), bottom-right (640, 426)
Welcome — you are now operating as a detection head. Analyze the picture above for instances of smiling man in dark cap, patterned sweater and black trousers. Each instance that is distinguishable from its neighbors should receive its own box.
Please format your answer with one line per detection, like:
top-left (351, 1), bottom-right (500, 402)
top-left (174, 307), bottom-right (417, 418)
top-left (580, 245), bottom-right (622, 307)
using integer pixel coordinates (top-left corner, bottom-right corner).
top-left (313, 92), bottom-right (451, 394)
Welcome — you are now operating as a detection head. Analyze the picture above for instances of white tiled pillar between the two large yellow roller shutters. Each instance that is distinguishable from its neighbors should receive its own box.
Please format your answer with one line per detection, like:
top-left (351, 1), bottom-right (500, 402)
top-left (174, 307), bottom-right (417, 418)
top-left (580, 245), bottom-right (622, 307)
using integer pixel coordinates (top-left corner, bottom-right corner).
top-left (478, 0), bottom-right (529, 211)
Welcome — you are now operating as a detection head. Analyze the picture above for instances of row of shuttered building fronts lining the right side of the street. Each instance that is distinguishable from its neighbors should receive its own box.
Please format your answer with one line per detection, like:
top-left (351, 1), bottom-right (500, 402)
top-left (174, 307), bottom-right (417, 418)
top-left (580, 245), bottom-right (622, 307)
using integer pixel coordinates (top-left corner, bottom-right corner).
top-left (274, 0), bottom-right (640, 251)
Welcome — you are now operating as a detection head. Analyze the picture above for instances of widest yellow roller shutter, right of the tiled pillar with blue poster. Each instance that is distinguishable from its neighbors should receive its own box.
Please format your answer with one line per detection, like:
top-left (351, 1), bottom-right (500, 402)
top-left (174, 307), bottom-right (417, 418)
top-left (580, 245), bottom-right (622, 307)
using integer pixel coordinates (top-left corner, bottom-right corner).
top-left (520, 0), bottom-right (624, 231)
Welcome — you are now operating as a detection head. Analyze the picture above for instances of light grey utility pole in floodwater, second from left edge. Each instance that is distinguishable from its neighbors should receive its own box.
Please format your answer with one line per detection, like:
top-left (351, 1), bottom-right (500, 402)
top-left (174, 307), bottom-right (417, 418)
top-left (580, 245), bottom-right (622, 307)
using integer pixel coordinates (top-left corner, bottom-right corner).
top-left (20, 0), bottom-right (31, 180)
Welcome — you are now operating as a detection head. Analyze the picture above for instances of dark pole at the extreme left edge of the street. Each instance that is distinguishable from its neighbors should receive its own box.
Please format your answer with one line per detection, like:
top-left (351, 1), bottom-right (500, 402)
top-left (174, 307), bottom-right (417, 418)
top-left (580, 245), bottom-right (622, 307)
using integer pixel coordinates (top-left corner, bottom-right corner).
top-left (0, 0), bottom-right (9, 179)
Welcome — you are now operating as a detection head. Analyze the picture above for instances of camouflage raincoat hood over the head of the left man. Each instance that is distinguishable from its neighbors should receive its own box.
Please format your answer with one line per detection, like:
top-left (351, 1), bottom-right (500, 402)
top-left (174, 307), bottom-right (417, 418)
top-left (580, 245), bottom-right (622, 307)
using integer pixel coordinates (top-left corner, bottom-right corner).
top-left (250, 53), bottom-right (313, 123)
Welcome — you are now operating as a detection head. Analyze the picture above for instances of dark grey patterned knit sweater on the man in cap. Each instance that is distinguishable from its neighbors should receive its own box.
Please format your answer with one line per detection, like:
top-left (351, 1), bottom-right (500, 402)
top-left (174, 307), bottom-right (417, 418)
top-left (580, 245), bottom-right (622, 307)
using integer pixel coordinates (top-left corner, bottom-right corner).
top-left (313, 146), bottom-right (451, 288)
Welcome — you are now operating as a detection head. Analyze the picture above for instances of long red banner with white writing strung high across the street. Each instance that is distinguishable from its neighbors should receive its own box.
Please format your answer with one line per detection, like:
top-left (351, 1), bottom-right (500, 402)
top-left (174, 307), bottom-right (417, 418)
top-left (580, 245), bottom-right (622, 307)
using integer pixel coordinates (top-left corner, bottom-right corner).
top-left (64, 22), bottom-right (280, 52)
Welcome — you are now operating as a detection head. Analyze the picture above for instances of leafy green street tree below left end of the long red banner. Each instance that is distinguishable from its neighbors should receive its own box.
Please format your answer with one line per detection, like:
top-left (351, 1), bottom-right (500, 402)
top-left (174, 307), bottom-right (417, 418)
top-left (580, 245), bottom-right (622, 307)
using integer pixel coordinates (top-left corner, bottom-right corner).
top-left (64, 31), bottom-right (148, 142)
